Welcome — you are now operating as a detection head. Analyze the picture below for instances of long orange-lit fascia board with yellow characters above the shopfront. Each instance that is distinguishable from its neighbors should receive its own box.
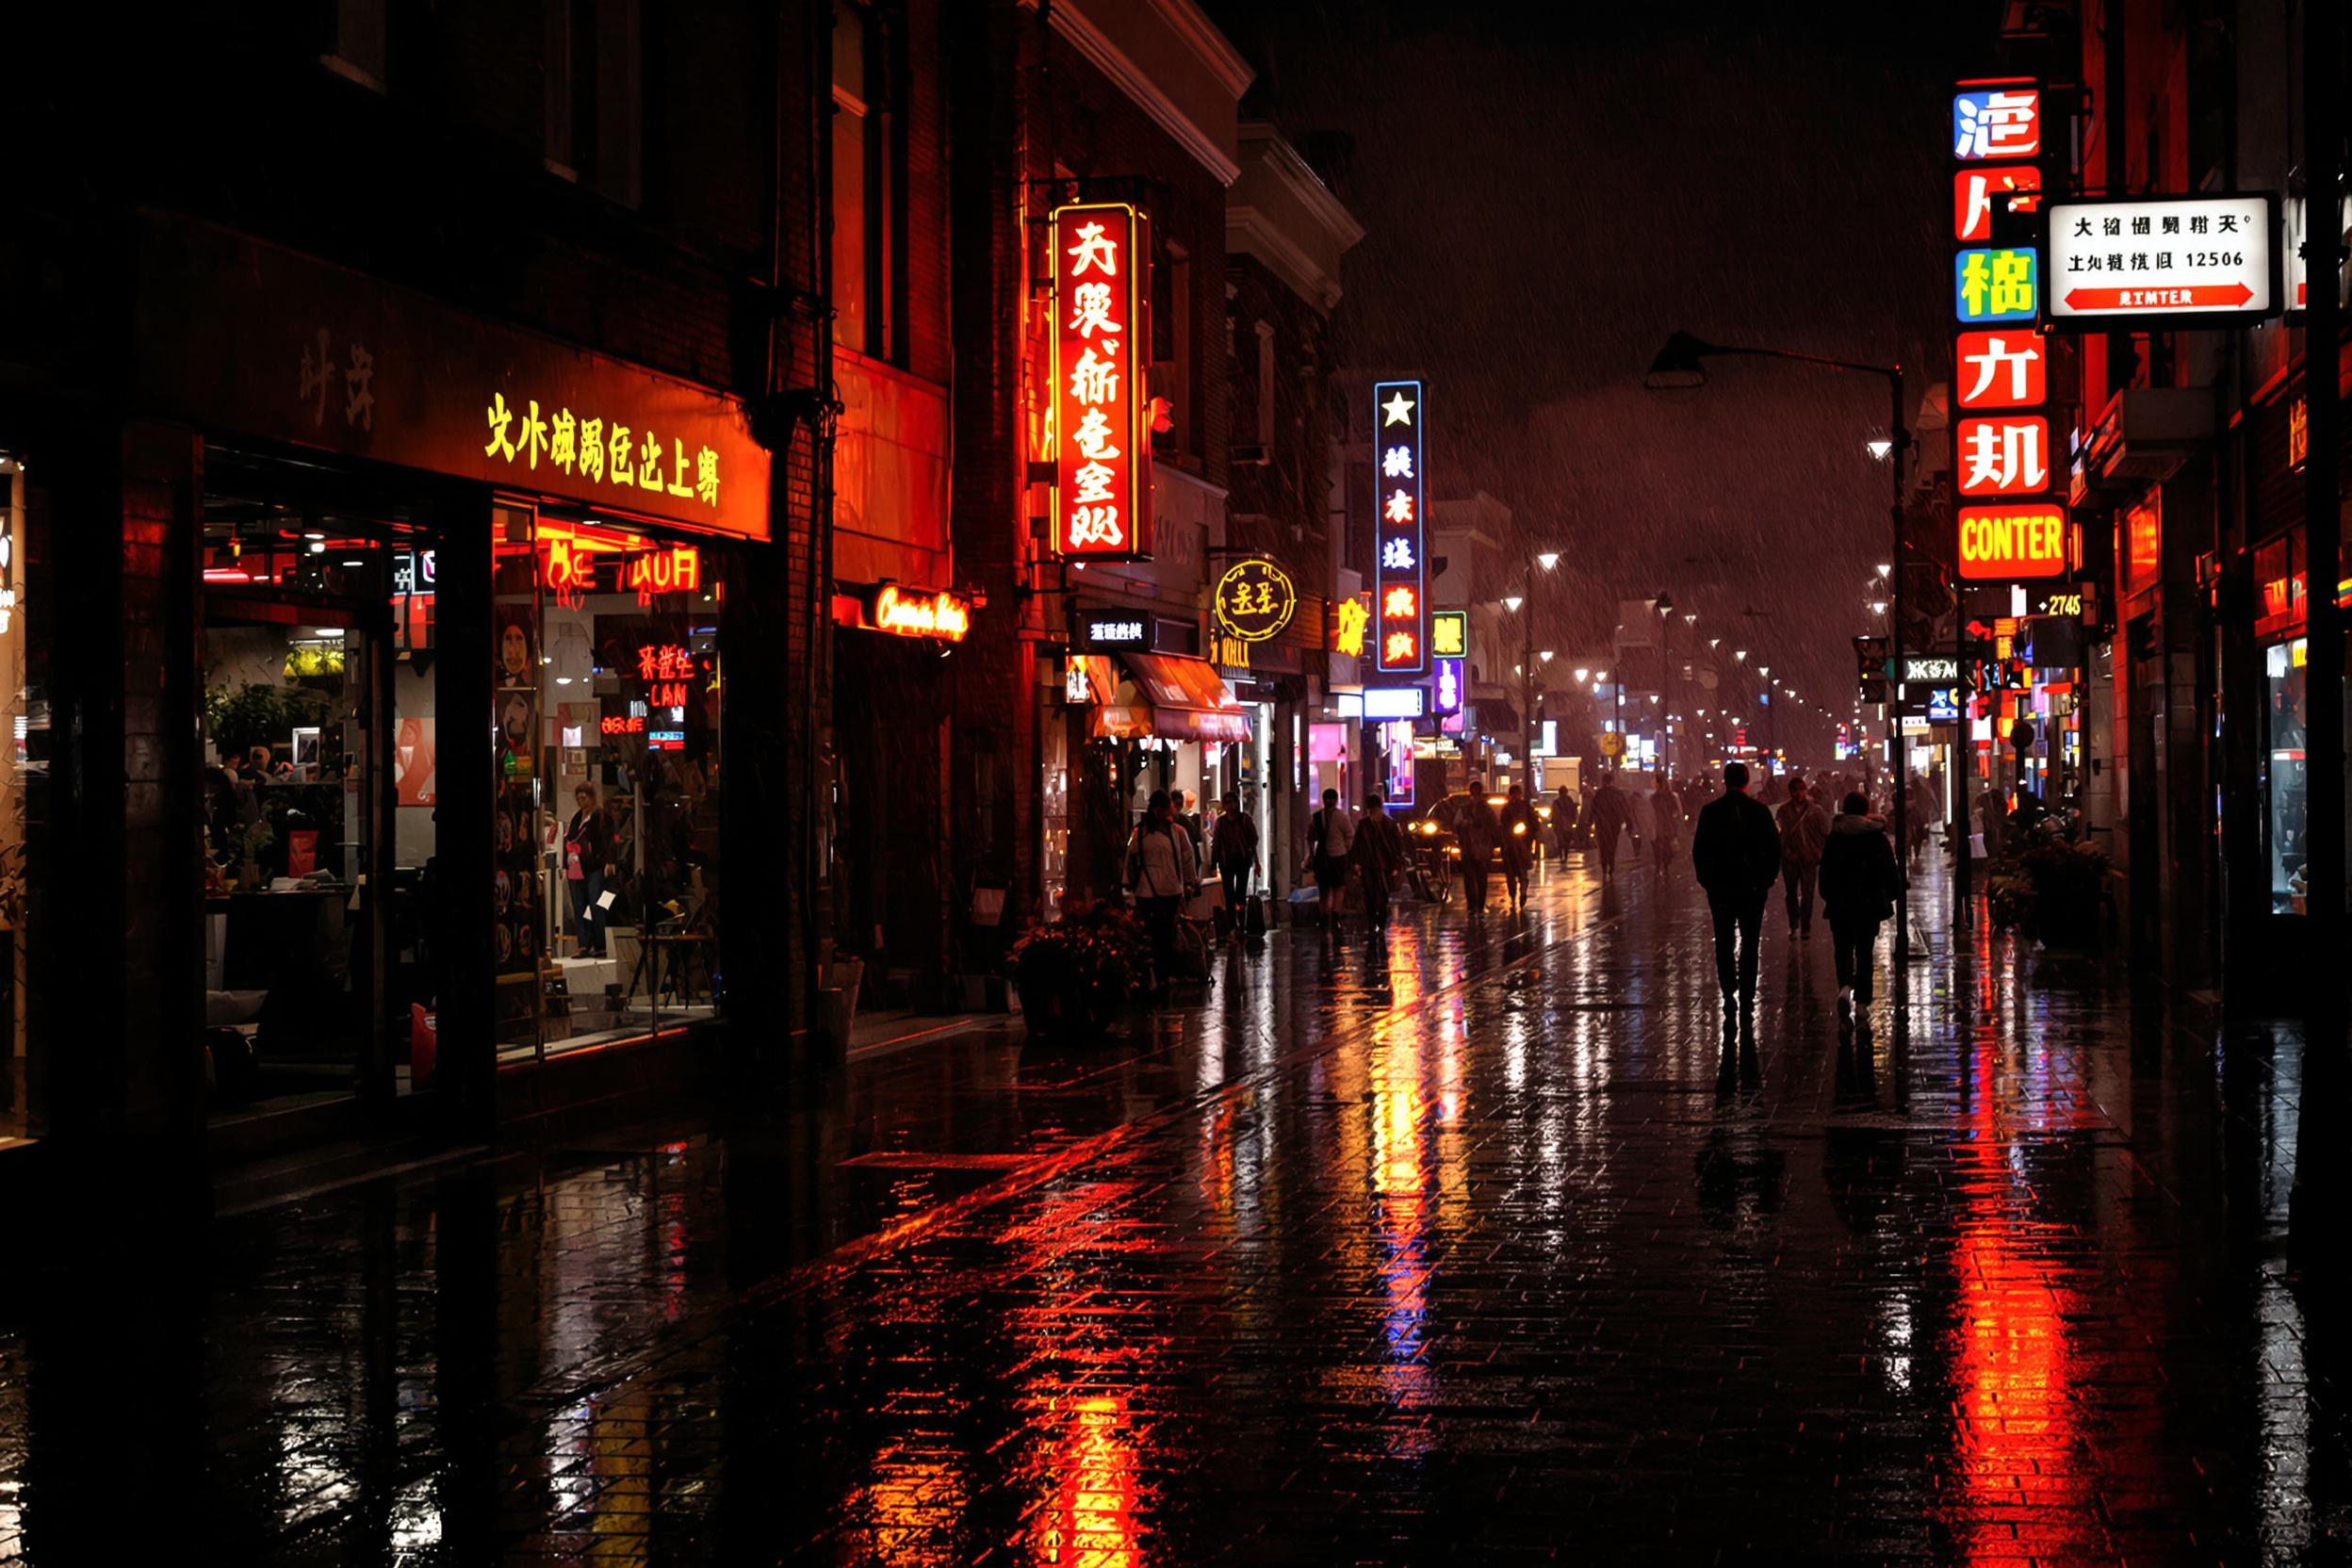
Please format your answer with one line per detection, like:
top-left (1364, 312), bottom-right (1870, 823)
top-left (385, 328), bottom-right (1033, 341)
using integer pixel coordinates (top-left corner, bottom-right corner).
top-left (132, 219), bottom-right (769, 538)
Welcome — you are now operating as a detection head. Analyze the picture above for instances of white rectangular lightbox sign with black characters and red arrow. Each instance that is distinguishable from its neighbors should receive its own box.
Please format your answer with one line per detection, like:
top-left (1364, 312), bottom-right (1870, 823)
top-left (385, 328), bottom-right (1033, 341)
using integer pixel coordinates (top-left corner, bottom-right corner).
top-left (2044, 195), bottom-right (2279, 332)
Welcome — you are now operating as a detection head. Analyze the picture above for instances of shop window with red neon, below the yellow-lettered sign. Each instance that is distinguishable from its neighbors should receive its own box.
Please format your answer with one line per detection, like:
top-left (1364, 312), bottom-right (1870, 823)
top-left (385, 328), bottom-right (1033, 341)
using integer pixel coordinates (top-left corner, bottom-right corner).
top-left (492, 508), bottom-right (725, 1058)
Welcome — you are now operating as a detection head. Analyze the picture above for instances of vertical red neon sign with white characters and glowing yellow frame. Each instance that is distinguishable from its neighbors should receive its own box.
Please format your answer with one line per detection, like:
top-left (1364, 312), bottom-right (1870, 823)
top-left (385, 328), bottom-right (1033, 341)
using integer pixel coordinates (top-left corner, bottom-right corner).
top-left (1052, 203), bottom-right (1151, 562)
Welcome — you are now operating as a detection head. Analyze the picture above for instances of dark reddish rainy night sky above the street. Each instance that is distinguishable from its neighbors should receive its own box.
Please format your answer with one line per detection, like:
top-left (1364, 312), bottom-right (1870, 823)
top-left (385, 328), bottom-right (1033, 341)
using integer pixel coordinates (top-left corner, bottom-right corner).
top-left (1209, 0), bottom-right (1959, 743)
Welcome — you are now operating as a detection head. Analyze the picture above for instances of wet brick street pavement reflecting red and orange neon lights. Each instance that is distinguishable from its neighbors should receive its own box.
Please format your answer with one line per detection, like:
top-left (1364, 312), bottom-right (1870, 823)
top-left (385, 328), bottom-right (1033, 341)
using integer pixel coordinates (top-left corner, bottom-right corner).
top-left (0, 865), bottom-right (2352, 1566)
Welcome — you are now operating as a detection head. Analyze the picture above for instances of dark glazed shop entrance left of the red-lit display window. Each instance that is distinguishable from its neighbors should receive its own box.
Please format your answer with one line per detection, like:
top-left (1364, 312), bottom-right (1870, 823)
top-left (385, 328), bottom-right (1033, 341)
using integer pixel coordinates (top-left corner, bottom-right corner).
top-left (198, 449), bottom-right (431, 1126)
